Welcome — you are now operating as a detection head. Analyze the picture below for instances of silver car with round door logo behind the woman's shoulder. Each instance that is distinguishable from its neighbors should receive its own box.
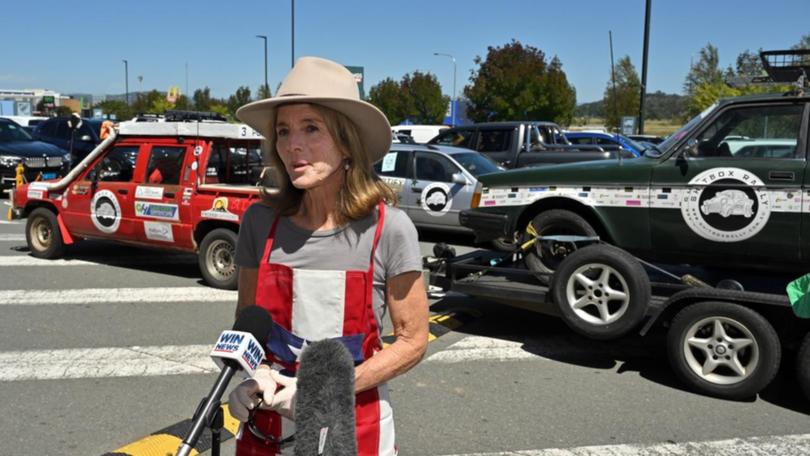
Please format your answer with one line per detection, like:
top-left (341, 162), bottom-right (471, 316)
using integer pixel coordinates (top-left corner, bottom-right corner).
top-left (374, 144), bottom-right (503, 232)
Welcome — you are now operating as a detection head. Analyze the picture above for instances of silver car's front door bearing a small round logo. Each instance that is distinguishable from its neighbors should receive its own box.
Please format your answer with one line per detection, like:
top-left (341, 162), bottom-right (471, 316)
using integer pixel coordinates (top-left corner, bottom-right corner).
top-left (409, 151), bottom-right (472, 228)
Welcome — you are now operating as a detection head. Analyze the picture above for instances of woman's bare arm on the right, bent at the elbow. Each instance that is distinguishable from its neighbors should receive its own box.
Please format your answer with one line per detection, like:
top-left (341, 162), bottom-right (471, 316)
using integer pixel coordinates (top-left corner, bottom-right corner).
top-left (354, 271), bottom-right (428, 392)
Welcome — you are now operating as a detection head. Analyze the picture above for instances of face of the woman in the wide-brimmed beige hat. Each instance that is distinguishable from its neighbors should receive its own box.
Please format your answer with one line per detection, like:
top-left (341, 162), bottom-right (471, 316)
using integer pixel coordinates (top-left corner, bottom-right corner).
top-left (276, 104), bottom-right (344, 190)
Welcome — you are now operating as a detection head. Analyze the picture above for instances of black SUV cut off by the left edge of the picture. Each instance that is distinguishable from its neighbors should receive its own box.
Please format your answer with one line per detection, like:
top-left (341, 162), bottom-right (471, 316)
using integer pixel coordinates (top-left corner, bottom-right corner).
top-left (0, 118), bottom-right (70, 189)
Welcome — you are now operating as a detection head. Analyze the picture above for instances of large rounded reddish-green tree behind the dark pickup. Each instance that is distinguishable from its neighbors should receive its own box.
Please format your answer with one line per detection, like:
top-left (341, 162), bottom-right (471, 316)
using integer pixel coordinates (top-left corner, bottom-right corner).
top-left (464, 40), bottom-right (576, 124)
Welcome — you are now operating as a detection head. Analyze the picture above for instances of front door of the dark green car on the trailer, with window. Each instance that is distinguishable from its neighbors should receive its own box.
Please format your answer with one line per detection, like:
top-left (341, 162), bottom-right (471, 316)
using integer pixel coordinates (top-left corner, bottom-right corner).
top-left (650, 102), bottom-right (807, 263)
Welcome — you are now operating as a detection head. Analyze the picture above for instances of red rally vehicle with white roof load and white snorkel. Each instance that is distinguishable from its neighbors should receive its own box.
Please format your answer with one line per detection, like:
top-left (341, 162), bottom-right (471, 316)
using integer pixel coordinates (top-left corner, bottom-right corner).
top-left (8, 118), bottom-right (265, 289)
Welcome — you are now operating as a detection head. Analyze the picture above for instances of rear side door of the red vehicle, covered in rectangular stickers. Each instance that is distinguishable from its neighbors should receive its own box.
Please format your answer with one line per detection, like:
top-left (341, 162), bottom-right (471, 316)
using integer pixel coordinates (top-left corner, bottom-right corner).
top-left (135, 142), bottom-right (191, 244)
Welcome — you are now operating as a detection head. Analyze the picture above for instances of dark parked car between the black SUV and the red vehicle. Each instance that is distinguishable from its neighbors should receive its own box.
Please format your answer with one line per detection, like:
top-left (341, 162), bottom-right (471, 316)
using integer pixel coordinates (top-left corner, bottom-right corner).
top-left (33, 117), bottom-right (103, 163)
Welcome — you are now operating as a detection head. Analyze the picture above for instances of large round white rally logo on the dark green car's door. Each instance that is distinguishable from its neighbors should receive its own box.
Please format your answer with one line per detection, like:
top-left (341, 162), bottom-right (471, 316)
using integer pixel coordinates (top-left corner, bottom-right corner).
top-left (681, 168), bottom-right (771, 242)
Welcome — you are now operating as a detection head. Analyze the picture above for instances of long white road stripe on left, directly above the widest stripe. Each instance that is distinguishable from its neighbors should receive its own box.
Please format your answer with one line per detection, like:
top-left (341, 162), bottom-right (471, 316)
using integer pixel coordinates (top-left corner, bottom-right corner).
top-left (0, 287), bottom-right (236, 306)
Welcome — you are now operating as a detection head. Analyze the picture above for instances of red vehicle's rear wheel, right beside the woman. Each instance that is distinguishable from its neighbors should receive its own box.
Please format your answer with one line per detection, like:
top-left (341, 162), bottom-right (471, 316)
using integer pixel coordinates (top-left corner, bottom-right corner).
top-left (199, 228), bottom-right (239, 290)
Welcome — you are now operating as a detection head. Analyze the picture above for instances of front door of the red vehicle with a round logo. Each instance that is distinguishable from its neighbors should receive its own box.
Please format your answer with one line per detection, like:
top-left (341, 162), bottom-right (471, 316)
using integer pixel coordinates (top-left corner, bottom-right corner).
top-left (61, 144), bottom-right (142, 240)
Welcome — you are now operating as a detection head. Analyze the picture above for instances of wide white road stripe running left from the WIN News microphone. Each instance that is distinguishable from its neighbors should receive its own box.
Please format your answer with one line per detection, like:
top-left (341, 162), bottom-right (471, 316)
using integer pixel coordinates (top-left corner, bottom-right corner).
top-left (0, 345), bottom-right (218, 382)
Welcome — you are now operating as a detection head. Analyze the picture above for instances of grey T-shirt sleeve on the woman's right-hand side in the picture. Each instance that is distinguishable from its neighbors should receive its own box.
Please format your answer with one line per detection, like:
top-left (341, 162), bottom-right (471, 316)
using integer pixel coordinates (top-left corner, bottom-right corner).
top-left (380, 207), bottom-right (422, 279)
